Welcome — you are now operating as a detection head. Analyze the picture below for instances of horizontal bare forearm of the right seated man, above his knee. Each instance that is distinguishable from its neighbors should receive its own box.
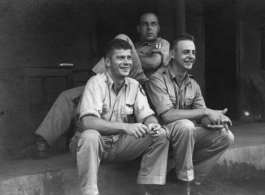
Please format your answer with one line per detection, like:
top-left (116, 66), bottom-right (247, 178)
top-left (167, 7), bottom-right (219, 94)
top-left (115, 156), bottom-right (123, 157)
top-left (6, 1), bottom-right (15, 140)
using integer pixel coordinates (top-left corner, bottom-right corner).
top-left (161, 108), bottom-right (208, 123)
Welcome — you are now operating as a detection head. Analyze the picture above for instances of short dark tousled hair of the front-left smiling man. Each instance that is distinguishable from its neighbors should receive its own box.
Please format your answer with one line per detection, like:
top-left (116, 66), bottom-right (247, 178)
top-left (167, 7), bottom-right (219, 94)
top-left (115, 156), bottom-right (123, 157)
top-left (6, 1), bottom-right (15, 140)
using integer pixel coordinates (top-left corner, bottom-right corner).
top-left (103, 39), bottom-right (132, 58)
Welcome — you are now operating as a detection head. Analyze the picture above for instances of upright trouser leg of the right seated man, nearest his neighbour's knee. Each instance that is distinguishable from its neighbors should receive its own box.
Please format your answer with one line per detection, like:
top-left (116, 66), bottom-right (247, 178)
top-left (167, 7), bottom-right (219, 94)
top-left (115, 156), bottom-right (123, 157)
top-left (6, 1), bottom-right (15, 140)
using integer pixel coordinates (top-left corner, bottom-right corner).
top-left (166, 119), bottom-right (196, 181)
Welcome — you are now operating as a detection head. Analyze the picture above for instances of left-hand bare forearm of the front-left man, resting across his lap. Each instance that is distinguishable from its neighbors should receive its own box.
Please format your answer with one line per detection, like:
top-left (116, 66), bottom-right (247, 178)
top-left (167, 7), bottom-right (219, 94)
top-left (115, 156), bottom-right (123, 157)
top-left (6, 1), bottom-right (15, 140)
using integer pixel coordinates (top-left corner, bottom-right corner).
top-left (82, 116), bottom-right (127, 134)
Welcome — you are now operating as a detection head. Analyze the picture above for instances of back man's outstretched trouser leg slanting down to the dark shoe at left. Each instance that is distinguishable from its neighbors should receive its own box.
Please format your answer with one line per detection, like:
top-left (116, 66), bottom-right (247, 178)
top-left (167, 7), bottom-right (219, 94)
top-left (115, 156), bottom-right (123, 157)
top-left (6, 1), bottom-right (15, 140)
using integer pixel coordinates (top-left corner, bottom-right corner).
top-left (35, 86), bottom-right (84, 145)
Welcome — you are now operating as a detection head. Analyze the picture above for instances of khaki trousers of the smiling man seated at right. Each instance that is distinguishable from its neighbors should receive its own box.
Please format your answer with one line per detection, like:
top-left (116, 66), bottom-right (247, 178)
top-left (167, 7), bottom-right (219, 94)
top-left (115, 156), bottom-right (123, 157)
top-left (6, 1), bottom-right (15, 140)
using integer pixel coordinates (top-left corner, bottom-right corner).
top-left (165, 119), bottom-right (234, 183)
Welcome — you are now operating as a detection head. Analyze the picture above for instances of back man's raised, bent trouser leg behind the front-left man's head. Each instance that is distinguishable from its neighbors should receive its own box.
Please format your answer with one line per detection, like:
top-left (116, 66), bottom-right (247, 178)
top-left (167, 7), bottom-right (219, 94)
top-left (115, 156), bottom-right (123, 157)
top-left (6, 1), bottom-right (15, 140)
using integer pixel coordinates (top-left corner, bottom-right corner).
top-left (92, 34), bottom-right (146, 84)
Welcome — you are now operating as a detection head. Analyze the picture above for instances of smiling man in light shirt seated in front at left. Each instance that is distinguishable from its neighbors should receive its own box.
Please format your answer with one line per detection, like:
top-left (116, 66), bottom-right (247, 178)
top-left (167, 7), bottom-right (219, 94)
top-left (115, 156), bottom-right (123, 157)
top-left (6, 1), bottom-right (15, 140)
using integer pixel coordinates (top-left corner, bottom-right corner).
top-left (70, 39), bottom-right (169, 195)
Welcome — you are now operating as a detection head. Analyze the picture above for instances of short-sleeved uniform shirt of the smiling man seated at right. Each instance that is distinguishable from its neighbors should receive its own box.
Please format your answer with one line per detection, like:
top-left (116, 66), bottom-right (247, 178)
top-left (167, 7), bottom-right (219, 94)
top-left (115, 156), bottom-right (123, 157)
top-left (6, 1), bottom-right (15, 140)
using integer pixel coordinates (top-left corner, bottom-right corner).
top-left (146, 64), bottom-right (206, 116)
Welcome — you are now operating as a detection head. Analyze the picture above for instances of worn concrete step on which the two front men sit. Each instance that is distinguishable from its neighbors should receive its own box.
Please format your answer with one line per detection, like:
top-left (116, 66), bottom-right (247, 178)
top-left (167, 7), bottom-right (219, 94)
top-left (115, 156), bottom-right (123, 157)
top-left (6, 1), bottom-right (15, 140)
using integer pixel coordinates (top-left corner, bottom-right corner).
top-left (0, 123), bottom-right (265, 195)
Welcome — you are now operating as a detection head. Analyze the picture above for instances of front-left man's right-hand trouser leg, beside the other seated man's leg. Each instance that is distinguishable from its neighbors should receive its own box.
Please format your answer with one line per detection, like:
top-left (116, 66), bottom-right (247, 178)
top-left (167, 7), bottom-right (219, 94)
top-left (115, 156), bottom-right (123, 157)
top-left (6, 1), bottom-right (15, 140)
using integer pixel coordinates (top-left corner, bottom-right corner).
top-left (106, 129), bottom-right (169, 185)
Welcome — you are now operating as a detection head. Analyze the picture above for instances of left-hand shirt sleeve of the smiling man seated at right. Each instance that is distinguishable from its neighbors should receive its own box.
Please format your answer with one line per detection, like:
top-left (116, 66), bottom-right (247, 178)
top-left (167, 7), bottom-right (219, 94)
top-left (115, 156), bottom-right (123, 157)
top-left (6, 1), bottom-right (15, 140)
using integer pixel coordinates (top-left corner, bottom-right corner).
top-left (146, 76), bottom-right (174, 117)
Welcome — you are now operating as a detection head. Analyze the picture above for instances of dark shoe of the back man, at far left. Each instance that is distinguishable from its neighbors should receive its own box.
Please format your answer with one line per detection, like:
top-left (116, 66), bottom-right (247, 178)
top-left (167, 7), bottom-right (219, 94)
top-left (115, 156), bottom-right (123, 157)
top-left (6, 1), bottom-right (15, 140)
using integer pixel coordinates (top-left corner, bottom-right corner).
top-left (32, 134), bottom-right (50, 159)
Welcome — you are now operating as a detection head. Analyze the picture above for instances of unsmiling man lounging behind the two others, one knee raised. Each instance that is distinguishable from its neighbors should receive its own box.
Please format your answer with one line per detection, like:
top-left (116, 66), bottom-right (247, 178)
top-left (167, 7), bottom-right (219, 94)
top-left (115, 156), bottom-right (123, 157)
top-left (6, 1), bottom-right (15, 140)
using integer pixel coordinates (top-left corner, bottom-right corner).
top-left (33, 13), bottom-right (170, 158)
